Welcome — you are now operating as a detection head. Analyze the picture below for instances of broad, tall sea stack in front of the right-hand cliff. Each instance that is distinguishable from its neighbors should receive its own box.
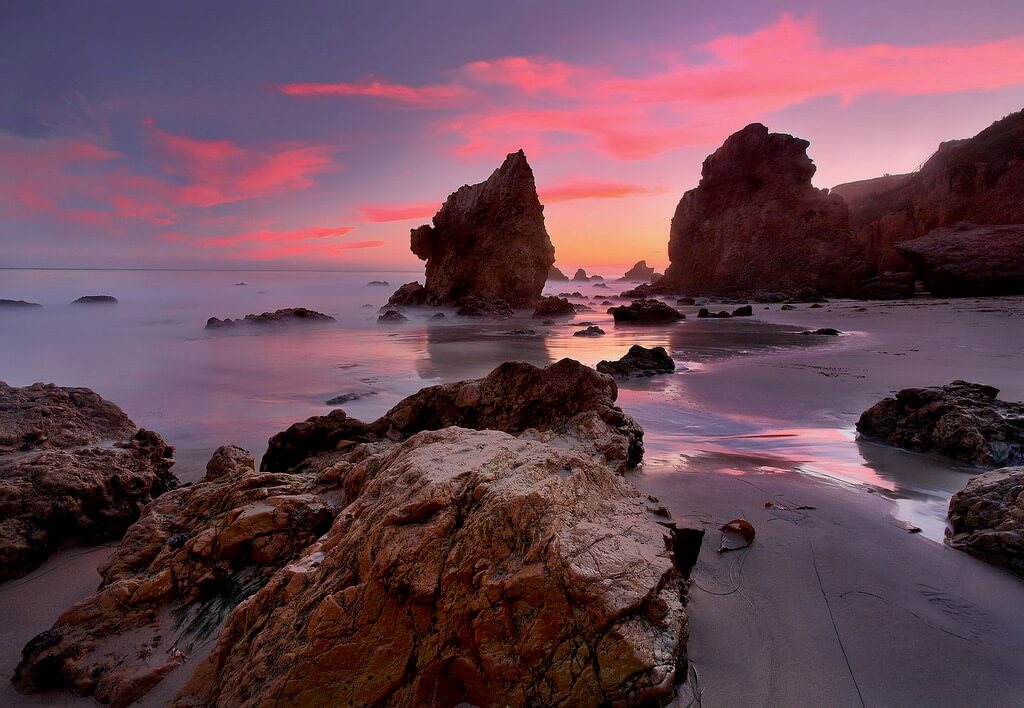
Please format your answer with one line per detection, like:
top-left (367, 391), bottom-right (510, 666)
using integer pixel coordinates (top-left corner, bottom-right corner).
top-left (657, 123), bottom-right (869, 295)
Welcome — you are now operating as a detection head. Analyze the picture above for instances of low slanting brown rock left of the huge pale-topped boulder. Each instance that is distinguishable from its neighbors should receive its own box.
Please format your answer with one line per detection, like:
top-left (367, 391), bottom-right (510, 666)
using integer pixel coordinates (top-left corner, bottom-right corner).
top-left (14, 447), bottom-right (333, 706)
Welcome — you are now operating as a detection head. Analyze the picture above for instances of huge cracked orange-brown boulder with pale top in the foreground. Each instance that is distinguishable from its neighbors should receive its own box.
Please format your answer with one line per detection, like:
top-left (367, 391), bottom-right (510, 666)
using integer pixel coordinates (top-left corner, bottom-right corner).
top-left (177, 427), bottom-right (686, 706)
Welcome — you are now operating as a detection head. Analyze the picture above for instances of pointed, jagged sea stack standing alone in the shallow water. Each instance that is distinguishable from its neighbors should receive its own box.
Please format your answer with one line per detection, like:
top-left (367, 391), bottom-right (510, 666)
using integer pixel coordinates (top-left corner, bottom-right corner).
top-left (403, 150), bottom-right (555, 307)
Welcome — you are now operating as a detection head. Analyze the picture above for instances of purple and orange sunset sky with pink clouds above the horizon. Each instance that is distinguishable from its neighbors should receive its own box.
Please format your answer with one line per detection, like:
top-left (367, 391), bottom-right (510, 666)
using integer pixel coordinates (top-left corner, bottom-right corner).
top-left (0, 0), bottom-right (1024, 275)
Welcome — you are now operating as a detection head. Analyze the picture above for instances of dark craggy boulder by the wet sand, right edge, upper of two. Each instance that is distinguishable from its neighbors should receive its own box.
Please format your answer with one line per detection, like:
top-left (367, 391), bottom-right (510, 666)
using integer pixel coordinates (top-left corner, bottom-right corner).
top-left (857, 381), bottom-right (1024, 467)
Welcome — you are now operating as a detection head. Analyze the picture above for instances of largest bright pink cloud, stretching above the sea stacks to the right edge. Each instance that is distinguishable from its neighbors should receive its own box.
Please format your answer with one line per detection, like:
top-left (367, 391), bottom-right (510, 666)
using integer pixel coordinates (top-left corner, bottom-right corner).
top-left (282, 13), bottom-right (1024, 160)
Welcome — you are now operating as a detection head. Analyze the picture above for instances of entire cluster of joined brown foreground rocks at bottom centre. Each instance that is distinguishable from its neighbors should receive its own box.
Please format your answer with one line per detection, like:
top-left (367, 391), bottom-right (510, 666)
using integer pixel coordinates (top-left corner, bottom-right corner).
top-left (15, 360), bottom-right (692, 706)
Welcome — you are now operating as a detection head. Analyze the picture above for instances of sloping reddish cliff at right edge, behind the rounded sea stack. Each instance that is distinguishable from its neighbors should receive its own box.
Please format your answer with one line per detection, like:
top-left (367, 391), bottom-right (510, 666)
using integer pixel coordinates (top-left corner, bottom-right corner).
top-left (834, 112), bottom-right (1024, 273)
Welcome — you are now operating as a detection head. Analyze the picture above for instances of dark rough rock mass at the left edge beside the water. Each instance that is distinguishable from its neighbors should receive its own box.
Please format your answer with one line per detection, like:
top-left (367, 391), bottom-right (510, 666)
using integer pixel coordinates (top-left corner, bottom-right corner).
top-left (0, 382), bottom-right (177, 581)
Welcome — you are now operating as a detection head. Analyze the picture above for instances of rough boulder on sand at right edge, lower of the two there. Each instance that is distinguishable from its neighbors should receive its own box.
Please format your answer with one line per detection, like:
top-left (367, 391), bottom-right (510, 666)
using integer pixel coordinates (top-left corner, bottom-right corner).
top-left (946, 467), bottom-right (1024, 576)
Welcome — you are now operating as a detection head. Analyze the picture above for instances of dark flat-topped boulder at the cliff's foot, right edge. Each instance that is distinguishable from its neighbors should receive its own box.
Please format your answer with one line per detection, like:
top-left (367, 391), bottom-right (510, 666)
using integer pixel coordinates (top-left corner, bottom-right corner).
top-left (895, 224), bottom-right (1024, 297)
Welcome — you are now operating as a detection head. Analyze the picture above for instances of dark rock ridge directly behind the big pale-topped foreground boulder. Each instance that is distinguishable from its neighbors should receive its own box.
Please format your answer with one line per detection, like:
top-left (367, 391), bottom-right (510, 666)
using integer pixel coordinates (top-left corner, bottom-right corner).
top-left (260, 359), bottom-right (643, 471)
